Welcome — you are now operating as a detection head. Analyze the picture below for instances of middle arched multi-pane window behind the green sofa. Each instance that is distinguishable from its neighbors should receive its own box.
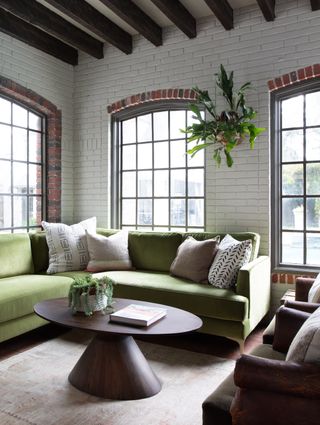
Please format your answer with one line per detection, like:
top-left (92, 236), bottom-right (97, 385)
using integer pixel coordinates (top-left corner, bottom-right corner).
top-left (112, 102), bottom-right (205, 231)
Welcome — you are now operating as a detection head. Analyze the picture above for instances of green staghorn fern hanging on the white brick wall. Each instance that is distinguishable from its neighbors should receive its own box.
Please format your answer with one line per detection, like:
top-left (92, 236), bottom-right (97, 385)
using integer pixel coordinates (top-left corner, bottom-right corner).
top-left (182, 65), bottom-right (265, 167)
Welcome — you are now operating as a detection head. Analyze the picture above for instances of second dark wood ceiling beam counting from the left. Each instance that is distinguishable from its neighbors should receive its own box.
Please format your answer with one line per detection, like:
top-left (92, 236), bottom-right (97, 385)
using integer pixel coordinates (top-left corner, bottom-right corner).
top-left (0, 0), bottom-right (103, 59)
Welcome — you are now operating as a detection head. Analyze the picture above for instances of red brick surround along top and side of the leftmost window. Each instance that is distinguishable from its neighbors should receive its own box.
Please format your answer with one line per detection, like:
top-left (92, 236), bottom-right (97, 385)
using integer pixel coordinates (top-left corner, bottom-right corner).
top-left (0, 76), bottom-right (61, 222)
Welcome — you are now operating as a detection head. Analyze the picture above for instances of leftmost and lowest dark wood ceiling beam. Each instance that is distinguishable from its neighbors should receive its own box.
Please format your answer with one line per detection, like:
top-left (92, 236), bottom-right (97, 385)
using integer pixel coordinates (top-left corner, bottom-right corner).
top-left (0, 8), bottom-right (78, 65)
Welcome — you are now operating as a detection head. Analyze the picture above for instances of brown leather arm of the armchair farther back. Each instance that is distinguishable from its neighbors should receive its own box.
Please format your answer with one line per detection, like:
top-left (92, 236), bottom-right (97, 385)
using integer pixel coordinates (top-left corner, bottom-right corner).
top-left (272, 306), bottom-right (311, 353)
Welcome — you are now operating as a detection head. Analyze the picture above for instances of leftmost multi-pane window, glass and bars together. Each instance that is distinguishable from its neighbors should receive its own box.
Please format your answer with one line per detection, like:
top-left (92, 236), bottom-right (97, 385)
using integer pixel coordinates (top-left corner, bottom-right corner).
top-left (0, 97), bottom-right (45, 233)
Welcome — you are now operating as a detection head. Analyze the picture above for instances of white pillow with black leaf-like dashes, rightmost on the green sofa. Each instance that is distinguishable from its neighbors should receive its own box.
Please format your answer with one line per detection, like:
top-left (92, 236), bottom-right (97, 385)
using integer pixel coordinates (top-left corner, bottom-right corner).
top-left (208, 235), bottom-right (252, 289)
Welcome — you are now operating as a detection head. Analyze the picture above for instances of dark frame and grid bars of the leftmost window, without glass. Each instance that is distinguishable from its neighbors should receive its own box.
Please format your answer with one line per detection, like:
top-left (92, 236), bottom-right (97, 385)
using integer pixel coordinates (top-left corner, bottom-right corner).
top-left (0, 93), bottom-right (48, 233)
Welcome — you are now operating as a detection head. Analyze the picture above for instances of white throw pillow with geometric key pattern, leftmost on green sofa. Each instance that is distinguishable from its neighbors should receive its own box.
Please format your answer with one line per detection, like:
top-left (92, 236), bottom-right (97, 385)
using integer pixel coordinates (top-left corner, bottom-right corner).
top-left (41, 217), bottom-right (97, 274)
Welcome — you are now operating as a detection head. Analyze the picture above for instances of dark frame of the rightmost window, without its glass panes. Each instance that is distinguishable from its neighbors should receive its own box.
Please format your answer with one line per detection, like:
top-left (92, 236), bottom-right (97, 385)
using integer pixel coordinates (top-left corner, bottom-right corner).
top-left (269, 78), bottom-right (320, 273)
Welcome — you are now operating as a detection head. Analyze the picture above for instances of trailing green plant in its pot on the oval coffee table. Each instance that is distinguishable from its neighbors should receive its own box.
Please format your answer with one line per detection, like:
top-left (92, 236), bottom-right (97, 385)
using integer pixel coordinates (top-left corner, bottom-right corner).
top-left (69, 275), bottom-right (114, 316)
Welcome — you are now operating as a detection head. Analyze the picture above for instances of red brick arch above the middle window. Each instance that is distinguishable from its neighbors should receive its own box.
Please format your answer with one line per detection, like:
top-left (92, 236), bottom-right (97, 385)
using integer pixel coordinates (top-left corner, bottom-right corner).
top-left (108, 89), bottom-right (196, 114)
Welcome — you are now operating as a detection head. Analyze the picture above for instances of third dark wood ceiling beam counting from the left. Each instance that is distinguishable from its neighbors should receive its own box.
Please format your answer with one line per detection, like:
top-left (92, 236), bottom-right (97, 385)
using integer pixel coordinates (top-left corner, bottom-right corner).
top-left (46, 0), bottom-right (132, 53)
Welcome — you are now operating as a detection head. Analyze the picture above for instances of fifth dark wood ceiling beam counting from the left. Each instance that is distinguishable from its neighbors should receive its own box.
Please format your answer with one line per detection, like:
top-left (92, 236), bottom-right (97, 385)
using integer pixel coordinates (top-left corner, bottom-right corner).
top-left (151, 0), bottom-right (197, 38)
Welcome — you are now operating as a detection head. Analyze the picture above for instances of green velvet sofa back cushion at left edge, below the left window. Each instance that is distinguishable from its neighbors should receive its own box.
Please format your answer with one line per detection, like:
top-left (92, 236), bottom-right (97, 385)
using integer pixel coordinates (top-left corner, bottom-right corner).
top-left (0, 233), bottom-right (34, 278)
